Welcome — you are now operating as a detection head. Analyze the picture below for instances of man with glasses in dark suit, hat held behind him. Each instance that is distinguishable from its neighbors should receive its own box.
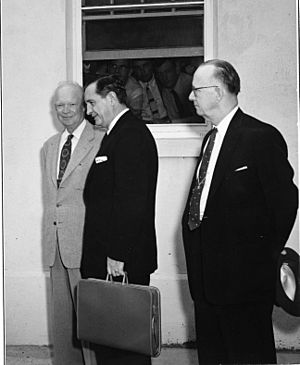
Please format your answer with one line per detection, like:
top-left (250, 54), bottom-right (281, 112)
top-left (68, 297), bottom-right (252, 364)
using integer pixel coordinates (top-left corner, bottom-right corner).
top-left (182, 60), bottom-right (298, 364)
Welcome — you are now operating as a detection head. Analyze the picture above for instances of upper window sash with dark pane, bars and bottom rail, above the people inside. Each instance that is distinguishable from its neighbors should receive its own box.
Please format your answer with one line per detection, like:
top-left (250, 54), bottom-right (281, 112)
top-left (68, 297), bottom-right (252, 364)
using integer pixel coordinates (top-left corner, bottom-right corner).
top-left (82, 0), bottom-right (204, 60)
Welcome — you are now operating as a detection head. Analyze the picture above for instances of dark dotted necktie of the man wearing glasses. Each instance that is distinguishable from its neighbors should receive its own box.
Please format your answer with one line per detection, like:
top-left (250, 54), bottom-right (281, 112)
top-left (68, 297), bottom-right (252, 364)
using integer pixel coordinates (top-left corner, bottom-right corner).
top-left (188, 128), bottom-right (217, 231)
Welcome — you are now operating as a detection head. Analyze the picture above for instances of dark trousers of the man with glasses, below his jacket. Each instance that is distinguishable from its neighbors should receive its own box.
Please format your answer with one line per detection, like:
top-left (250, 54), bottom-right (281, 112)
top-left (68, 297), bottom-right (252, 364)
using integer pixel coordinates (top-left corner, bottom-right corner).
top-left (195, 301), bottom-right (276, 364)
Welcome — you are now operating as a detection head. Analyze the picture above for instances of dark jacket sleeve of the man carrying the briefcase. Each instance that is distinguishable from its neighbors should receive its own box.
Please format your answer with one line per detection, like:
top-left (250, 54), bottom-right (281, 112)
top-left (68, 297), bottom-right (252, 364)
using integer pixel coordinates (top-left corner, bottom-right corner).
top-left (107, 129), bottom-right (156, 261)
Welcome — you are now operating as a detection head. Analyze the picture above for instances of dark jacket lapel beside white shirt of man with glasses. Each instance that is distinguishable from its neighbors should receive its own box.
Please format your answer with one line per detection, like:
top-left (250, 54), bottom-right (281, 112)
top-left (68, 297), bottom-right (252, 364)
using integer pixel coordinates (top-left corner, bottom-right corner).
top-left (207, 109), bottom-right (243, 204)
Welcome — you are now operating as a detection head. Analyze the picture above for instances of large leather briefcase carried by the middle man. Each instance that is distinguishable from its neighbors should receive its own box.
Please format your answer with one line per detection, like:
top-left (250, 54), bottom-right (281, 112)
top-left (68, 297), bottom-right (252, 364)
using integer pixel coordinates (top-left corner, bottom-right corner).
top-left (77, 279), bottom-right (161, 357)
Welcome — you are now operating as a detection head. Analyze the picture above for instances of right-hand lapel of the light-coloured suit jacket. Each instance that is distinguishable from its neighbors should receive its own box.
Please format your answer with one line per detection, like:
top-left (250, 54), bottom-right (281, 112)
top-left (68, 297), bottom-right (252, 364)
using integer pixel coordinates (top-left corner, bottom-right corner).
top-left (62, 122), bottom-right (95, 181)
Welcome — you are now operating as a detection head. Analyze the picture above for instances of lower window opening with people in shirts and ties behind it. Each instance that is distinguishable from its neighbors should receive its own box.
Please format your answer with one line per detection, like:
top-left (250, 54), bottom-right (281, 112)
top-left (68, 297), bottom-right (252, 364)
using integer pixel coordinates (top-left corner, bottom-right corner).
top-left (83, 57), bottom-right (204, 124)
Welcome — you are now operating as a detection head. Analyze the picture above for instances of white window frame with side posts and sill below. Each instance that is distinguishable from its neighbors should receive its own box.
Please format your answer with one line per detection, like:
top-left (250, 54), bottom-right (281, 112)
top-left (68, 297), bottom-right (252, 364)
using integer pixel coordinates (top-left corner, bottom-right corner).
top-left (66, 0), bottom-right (218, 152)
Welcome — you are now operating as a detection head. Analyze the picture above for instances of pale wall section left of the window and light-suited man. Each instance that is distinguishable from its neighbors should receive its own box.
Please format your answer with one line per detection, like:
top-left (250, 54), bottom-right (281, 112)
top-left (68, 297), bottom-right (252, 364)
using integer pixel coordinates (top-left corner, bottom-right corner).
top-left (2, 0), bottom-right (66, 344)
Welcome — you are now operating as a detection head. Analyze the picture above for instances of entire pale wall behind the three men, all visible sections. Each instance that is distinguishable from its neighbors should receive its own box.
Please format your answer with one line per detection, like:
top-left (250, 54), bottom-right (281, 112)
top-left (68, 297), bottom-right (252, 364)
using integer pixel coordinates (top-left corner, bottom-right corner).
top-left (2, 0), bottom-right (299, 348)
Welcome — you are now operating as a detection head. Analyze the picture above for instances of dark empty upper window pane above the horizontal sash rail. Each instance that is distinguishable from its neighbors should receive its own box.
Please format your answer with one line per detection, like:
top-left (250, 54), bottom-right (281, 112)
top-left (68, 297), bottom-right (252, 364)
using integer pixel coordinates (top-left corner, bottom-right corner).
top-left (85, 16), bottom-right (203, 51)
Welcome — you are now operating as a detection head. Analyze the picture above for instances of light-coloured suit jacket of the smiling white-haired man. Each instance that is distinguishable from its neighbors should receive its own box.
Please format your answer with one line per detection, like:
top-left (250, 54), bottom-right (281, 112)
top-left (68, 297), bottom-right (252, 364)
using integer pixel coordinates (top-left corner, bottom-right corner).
top-left (42, 122), bottom-right (103, 268)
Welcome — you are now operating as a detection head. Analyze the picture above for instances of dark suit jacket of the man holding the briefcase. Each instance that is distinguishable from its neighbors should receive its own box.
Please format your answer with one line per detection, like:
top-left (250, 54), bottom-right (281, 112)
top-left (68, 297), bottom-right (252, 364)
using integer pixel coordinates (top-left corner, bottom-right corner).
top-left (81, 111), bottom-right (158, 278)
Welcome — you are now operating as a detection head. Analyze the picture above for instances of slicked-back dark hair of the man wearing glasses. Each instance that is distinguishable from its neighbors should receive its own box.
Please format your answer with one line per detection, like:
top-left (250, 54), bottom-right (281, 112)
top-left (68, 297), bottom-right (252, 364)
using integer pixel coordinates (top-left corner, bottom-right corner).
top-left (201, 59), bottom-right (241, 95)
